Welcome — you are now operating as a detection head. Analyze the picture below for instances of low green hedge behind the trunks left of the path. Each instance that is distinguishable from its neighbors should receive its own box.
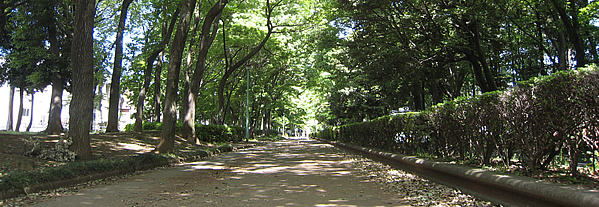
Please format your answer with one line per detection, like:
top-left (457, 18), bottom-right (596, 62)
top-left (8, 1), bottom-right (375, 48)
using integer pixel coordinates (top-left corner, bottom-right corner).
top-left (125, 122), bottom-right (245, 143)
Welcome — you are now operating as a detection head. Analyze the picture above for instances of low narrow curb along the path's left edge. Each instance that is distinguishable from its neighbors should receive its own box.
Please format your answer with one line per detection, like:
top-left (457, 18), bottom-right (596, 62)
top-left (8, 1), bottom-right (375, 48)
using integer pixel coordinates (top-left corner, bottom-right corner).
top-left (0, 144), bottom-right (255, 200)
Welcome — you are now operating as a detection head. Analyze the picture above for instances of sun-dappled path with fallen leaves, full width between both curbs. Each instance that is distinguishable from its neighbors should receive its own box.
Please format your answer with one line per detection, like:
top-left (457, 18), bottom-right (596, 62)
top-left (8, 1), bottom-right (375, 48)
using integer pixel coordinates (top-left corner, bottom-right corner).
top-left (0, 140), bottom-right (491, 207)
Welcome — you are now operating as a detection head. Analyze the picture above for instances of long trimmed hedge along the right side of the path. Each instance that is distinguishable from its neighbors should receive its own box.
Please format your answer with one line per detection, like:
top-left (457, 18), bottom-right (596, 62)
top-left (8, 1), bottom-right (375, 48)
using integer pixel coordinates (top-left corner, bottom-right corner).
top-left (317, 67), bottom-right (599, 173)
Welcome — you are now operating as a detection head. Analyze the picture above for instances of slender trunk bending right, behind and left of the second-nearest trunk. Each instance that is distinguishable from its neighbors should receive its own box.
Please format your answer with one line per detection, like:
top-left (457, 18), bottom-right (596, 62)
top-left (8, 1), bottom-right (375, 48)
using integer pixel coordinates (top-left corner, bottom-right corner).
top-left (133, 9), bottom-right (180, 132)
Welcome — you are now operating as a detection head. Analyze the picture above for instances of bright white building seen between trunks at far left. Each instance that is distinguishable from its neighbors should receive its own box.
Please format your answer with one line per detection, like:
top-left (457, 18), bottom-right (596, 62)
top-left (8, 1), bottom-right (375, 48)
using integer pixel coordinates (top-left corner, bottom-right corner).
top-left (0, 84), bottom-right (135, 132)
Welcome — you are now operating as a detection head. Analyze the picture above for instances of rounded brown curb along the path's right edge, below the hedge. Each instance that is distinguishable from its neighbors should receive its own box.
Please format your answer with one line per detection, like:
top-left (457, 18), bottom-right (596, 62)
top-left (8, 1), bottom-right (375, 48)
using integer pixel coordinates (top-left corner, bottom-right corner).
top-left (319, 139), bottom-right (599, 207)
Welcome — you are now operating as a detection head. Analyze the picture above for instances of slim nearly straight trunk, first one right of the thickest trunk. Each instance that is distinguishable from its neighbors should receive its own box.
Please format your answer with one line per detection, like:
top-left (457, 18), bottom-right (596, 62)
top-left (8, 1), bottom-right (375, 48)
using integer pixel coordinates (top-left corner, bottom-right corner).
top-left (106, 0), bottom-right (133, 132)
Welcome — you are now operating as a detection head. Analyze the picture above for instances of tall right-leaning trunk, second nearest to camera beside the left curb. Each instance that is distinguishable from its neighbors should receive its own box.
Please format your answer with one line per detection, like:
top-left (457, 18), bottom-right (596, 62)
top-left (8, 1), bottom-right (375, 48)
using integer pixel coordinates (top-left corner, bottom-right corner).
top-left (155, 0), bottom-right (196, 153)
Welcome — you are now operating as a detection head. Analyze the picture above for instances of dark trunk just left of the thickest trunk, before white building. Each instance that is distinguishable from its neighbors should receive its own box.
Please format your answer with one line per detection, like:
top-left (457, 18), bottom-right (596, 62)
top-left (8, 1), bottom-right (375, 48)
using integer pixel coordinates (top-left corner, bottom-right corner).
top-left (46, 19), bottom-right (66, 135)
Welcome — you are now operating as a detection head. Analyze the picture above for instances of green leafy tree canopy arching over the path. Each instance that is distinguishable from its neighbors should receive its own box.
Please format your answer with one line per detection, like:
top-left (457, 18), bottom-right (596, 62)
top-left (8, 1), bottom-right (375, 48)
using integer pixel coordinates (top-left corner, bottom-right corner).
top-left (0, 0), bottom-right (599, 155)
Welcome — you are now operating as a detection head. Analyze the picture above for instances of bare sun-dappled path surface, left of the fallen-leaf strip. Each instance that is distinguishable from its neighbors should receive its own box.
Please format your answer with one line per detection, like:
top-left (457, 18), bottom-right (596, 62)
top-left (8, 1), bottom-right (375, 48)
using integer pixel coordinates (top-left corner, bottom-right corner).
top-left (31, 140), bottom-right (406, 207)
